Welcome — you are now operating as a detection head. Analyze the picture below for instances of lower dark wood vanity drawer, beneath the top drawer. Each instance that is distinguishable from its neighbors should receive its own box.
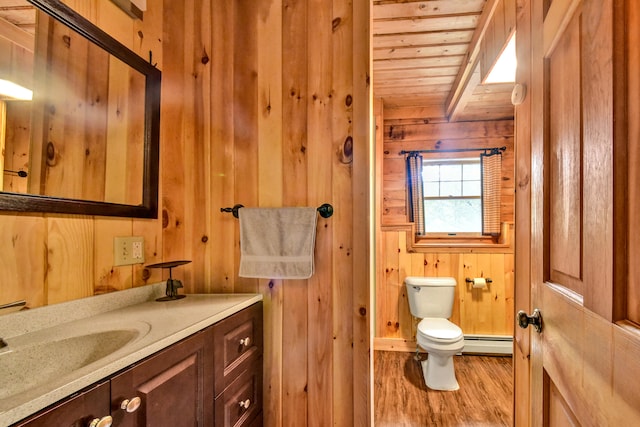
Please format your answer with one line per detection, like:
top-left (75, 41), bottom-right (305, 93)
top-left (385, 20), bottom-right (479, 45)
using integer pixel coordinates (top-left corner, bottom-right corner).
top-left (215, 358), bottom-right (262, 427)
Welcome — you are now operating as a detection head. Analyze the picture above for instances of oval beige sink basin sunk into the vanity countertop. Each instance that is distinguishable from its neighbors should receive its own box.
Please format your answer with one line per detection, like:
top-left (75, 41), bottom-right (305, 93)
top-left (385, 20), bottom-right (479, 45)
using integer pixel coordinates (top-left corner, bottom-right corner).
top-left (0, 322), bottom-right (150, 400)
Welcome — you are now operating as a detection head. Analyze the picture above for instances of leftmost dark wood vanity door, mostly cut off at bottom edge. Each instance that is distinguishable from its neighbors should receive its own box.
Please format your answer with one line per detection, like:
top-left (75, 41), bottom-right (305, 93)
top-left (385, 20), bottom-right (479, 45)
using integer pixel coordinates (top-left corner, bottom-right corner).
top-left (14, 381), bottom-right (109, 427)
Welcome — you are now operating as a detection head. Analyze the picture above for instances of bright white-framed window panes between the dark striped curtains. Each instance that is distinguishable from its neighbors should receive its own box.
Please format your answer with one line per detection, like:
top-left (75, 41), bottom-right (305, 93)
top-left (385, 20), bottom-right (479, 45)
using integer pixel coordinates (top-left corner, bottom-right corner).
top-left (422, 158), bottom-right (482, 234)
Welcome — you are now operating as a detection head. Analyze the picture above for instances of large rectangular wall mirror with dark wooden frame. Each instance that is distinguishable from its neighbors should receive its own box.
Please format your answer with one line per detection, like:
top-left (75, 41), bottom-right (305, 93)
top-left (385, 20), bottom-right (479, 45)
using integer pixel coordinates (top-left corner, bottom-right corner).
top-left (0, 0), bottom-right (161, 218)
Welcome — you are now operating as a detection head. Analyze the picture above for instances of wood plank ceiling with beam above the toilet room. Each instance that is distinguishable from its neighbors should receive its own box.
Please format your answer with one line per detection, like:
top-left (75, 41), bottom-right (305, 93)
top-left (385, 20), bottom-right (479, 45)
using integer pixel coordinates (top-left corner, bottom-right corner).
top-left (372, 0), bottom-right (515, 121)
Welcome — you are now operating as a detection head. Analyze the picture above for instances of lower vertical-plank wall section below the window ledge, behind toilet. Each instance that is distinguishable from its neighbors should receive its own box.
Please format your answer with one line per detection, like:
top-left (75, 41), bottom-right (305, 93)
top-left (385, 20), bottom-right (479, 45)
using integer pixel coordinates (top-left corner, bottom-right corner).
top-left (375, 231), bottom-right (514, 351)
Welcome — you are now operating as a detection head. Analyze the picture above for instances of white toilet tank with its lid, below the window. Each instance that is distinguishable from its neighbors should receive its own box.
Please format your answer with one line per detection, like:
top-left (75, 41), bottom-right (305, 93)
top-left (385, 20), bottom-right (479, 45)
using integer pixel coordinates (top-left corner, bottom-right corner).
top-left (404, 277), bottom-right (456, 319)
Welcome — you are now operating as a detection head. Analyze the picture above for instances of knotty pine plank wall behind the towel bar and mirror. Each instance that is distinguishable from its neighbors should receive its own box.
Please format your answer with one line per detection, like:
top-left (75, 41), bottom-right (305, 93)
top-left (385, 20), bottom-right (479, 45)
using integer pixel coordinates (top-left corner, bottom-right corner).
top-left (0, 0), bottom-right (372, 426)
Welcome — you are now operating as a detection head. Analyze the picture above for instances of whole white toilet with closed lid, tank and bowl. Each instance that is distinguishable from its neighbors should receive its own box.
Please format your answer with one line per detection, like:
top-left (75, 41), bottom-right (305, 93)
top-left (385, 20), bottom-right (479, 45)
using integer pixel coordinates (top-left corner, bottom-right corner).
top-left (404, 277), bottom-right (464, 390)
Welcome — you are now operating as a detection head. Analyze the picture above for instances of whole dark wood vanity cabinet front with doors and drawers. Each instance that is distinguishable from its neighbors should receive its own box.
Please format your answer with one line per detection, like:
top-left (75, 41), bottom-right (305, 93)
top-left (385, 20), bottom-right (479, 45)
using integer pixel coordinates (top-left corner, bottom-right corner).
top-left (15, 302), bottom-right (262, 427)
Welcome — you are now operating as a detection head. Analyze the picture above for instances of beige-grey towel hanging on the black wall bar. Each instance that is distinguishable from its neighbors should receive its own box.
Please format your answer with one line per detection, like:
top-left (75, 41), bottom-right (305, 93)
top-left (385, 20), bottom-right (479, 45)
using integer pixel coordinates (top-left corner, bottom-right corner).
top-left (238, 207), bottom-right (317, 279)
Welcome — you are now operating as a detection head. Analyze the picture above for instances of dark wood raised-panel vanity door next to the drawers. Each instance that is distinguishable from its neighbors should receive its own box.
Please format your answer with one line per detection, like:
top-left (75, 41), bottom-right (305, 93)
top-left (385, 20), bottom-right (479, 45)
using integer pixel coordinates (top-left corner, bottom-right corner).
top-left (111, 329), bottom-right (213, 427)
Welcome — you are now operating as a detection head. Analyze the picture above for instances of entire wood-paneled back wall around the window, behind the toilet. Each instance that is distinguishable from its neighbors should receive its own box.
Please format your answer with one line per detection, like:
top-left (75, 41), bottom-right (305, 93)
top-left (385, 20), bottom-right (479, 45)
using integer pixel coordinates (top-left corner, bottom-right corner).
top-left (375, 109), bottom-right (515, 351)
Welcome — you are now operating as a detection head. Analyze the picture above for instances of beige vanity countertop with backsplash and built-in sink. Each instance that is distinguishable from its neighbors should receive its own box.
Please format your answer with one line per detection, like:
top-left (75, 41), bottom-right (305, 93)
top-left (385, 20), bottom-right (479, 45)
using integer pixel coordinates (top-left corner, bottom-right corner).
top-left (0, 283), bottom-right (262, 426)
